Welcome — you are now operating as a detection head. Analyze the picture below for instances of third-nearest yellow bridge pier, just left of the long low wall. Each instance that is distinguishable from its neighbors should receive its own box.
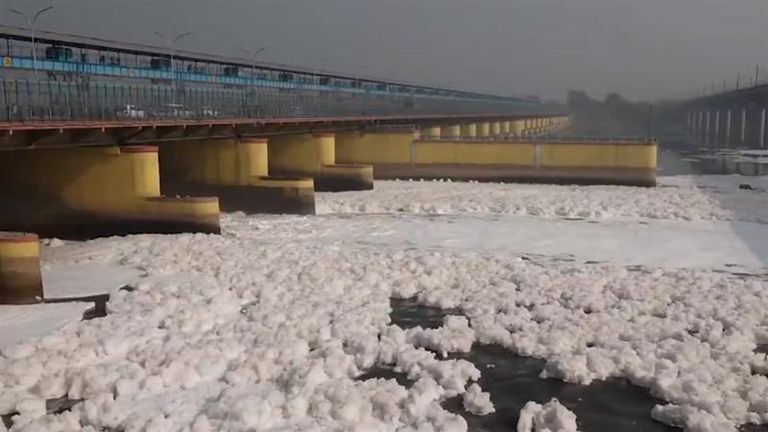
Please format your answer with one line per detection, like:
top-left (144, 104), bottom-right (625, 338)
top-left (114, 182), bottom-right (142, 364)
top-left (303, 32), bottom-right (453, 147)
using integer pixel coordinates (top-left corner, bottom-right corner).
top-left (269, 133), bottom-right (373, 192)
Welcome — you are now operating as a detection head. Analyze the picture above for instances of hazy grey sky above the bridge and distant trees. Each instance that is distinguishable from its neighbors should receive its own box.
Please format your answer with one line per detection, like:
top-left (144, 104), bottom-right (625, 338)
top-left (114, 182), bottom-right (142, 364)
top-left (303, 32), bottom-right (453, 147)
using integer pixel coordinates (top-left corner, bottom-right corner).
top-left (0, 0), bottom-right (768, 99)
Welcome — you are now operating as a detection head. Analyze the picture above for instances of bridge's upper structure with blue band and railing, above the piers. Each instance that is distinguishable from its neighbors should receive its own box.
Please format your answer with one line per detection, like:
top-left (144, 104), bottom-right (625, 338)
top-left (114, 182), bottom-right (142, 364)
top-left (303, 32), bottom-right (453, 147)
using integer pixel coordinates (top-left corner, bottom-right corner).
top-left (0, 26), bottom-right (546, 121)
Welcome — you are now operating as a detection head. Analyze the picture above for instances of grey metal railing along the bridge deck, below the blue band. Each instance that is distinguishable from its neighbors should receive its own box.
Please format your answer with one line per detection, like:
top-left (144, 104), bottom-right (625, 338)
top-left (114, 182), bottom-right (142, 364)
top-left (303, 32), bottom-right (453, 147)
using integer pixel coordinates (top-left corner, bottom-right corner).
top-left (0, 79), bottom-right (541, 122)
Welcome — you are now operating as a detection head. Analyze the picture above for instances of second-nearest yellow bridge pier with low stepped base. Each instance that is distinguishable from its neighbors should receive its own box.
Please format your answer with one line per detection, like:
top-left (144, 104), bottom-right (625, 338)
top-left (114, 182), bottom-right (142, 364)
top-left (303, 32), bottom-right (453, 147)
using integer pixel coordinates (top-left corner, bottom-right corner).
top-left (160, 138), bottom-right (315, 214)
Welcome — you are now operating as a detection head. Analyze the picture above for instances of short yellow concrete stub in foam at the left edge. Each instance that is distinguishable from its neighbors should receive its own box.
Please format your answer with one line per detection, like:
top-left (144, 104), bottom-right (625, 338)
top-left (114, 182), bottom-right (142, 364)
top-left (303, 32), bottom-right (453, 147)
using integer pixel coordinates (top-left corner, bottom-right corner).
top-left (0, 231), bottom-right (43, 304)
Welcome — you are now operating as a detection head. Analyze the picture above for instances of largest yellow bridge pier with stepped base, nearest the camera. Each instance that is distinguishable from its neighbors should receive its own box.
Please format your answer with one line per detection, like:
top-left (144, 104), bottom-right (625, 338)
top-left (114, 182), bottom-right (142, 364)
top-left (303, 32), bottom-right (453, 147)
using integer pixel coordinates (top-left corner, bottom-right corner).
top-left (0, 146), bottom-right (219, 239)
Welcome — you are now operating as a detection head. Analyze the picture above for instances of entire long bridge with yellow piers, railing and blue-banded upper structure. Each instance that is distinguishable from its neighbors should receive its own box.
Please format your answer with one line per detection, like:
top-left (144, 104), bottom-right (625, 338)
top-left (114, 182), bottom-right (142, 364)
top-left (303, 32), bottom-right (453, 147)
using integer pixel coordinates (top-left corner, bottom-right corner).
top-left (0, 27), bottom-right (656, 243)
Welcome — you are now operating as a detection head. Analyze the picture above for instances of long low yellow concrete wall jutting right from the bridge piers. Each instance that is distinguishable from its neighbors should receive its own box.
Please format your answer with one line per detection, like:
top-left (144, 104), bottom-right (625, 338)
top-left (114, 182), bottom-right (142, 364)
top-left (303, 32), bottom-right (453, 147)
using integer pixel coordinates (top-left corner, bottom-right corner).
top-left (332, 131), bottom-right (656, 186)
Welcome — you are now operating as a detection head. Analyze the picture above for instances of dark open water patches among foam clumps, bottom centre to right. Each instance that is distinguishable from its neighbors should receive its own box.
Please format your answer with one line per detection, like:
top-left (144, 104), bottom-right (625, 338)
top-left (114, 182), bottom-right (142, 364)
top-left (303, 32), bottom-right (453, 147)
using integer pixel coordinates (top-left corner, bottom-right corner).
top-left (360, 299), bottom-right (768, 432)
